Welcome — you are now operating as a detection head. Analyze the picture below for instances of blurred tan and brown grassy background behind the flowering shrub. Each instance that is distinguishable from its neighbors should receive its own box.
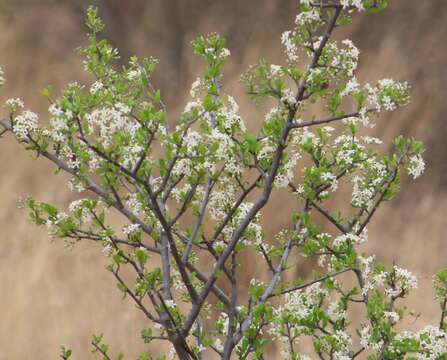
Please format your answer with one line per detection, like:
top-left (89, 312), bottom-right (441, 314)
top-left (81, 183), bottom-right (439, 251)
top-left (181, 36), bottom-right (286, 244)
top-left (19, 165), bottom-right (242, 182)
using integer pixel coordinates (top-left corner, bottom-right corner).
top-left (0, 0), bottom-right (447, 360)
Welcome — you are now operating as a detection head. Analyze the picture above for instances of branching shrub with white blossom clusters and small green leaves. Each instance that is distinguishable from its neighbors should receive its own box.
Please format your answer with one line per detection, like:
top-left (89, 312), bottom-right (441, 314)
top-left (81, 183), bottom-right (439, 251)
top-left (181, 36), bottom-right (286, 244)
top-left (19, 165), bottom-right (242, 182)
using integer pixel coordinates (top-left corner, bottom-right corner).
top-left (0, 0), bottom-right (447, 360)
